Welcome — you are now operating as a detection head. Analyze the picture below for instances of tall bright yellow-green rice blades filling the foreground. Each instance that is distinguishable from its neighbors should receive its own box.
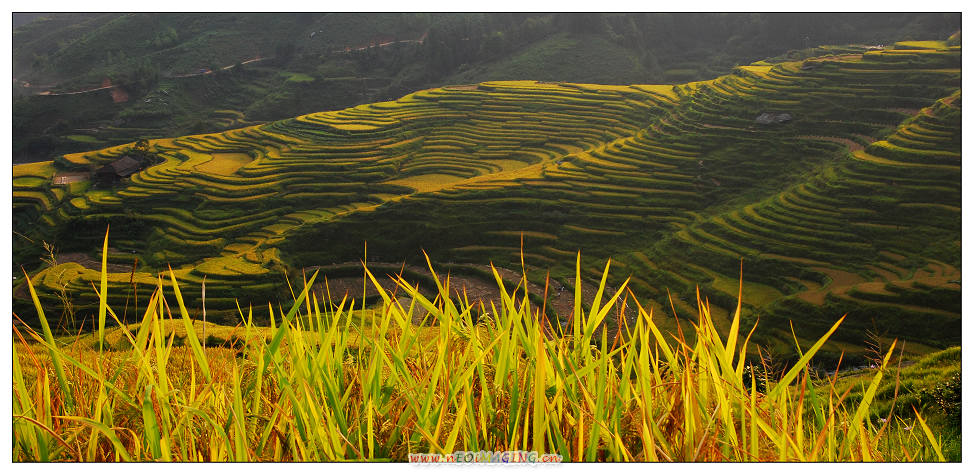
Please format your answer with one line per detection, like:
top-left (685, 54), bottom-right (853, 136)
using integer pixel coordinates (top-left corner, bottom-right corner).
top-left (13, 239), bottom-right (944, 461)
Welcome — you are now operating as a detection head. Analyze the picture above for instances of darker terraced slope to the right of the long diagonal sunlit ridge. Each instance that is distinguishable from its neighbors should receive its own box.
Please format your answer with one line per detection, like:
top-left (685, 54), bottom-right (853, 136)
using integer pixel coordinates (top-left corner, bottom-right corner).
top-left (284, 44), bottom-right (960, 352)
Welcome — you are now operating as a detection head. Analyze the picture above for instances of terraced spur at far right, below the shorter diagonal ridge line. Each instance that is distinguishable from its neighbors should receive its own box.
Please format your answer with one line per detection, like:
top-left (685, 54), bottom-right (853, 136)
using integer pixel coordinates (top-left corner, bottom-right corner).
top-left (668, 92), bottom-right (961, 345)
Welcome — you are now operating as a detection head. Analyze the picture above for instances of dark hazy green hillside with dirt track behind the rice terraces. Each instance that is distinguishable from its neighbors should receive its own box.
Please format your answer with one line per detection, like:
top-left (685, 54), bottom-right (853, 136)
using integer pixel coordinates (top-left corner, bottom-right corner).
top-left (13, 13), bottom-right (960, 163)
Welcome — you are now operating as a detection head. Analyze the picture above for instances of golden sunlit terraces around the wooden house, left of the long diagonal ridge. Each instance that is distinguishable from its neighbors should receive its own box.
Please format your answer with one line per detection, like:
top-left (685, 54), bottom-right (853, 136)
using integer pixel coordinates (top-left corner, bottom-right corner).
top-left (14, 81), bottom-right (675, 308)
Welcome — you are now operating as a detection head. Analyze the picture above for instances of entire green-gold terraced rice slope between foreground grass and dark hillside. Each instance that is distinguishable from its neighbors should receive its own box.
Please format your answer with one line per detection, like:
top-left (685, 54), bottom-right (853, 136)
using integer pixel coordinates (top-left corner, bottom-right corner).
top-left (14, 43), bottom-right (961, 358)
